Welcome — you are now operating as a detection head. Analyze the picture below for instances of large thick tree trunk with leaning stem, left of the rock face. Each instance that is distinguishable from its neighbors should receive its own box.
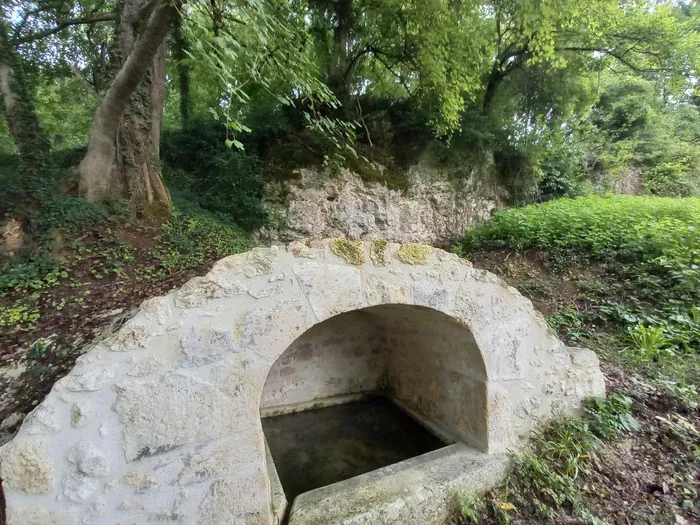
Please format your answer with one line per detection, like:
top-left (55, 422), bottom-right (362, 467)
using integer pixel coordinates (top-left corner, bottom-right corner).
top-left (78, 0), bottom-right (181, 218)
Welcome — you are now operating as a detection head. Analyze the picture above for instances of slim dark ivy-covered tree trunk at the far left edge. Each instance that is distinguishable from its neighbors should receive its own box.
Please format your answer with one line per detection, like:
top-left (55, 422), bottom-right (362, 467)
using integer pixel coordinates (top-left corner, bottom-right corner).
top-left (0, 20), bottom-right (50, 188)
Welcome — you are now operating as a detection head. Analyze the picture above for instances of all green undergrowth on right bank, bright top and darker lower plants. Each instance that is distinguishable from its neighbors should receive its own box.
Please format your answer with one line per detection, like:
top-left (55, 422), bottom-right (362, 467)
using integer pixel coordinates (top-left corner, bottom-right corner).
top-left (455, 196), bottom-right (700, 408)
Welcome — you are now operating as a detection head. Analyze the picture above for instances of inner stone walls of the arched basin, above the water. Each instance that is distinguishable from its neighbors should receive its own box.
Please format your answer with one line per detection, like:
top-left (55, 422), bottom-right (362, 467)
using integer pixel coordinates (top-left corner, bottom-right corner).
top-left (260, 304), bottom-right (488, 451)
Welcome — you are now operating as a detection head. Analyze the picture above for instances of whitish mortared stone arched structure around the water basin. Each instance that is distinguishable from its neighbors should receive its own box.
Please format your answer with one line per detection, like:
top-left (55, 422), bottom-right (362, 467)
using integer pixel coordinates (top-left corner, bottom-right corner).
top-left (0, 240), bottom-right (604, 525)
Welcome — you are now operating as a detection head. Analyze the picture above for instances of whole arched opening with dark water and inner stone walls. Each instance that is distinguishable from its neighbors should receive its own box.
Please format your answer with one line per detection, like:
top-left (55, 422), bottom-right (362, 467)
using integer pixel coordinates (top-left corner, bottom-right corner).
top-left (260, 304), bottom-right (487, 503)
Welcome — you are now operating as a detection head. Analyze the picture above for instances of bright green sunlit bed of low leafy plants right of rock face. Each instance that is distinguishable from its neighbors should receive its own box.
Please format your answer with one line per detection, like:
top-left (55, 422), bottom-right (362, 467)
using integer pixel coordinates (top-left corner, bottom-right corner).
top-left (460, 196), bottom-right (700, 263)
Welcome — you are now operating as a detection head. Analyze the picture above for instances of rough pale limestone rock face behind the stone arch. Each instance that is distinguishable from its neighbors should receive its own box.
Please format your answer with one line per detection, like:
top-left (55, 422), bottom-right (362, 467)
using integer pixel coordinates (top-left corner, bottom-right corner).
top-left (261, 164), bottom-right (503, 245)
